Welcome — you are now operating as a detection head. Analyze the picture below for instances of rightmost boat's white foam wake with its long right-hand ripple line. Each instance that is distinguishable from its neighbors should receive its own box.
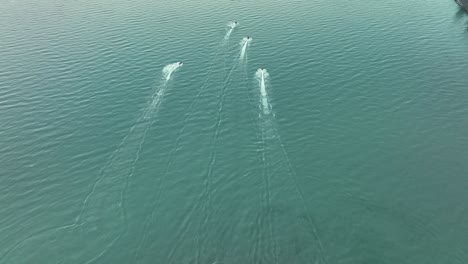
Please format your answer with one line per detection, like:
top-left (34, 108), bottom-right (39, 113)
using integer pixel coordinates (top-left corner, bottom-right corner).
top-left (255, 68), bottom-right (328, 263)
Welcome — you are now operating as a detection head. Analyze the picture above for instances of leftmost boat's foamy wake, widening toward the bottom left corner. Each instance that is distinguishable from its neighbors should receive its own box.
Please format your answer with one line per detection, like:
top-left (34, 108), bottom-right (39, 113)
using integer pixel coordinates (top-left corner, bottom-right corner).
top-left (0, 63), bottom-right (182, 263)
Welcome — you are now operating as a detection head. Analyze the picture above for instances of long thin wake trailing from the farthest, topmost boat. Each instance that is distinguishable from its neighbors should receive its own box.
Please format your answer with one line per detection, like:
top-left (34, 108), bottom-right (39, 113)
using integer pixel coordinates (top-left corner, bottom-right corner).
top-left (134, 22), bottom-right (238, 263)
